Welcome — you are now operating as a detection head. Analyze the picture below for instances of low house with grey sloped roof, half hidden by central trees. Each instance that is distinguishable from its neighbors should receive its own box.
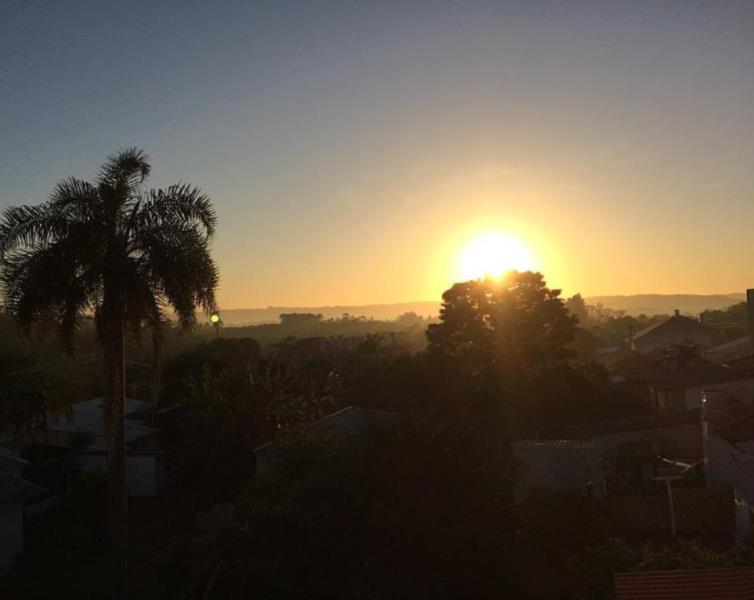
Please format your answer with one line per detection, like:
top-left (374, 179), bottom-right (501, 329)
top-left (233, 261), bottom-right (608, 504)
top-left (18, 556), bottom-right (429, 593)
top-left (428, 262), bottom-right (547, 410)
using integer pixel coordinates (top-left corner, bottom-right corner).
top-left (254, 406), bottom-right (396, 477)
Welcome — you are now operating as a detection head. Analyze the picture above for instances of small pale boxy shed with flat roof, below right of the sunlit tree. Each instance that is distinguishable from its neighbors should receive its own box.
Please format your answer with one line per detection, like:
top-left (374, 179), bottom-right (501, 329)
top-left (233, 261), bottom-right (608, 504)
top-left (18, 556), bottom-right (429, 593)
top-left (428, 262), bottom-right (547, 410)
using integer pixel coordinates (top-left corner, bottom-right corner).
top-left (511, 440), bottom-right (607, 502)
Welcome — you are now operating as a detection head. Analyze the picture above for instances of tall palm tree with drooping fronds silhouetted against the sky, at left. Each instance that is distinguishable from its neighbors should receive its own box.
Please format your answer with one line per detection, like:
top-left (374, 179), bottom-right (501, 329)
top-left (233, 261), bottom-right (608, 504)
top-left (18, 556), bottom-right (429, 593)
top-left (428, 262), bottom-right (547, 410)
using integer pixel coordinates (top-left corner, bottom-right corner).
top-left (0, 148), bottom-right (218, 552)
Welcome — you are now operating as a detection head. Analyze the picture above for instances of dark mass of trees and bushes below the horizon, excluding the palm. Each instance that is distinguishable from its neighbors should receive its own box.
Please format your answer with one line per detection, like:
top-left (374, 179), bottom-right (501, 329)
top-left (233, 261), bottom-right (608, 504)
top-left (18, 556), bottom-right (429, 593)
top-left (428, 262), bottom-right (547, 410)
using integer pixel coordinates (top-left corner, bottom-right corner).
top-left (0, 273), bottom-right (752, 598)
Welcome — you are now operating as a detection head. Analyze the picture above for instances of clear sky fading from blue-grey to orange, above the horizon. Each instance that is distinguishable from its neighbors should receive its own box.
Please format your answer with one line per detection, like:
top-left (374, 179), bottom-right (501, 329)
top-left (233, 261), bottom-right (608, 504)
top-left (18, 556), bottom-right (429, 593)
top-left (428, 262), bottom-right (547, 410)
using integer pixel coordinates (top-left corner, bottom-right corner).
top-left (0, 0), bottom-right (754, 308)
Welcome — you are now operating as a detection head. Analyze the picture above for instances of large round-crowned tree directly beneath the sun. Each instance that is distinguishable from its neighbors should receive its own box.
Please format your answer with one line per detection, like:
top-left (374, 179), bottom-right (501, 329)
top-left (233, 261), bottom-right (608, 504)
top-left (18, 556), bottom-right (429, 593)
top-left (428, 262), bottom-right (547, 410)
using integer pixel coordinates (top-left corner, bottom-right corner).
top-left (427, 271), bottom-right (576, 435)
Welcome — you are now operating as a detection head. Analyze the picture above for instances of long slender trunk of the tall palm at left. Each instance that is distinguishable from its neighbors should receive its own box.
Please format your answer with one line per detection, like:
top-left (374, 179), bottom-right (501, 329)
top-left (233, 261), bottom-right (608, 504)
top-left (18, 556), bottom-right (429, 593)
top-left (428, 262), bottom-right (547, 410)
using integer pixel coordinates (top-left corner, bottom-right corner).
top-left (102, 290), bottom-right (128, 587)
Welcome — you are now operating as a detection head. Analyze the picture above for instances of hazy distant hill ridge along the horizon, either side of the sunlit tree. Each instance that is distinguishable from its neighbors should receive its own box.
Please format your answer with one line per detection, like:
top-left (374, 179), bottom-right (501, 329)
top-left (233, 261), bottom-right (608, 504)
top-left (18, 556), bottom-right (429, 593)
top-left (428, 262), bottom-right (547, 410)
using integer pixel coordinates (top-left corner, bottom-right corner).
top-left (217, 294), bottom-right (746, 326)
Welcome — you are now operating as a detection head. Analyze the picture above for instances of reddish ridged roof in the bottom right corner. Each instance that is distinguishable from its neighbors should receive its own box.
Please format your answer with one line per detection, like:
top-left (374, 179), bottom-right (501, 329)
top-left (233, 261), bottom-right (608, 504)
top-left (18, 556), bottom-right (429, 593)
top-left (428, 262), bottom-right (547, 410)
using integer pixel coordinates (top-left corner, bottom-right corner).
top-left (613, 567), bottom-right (754, 600)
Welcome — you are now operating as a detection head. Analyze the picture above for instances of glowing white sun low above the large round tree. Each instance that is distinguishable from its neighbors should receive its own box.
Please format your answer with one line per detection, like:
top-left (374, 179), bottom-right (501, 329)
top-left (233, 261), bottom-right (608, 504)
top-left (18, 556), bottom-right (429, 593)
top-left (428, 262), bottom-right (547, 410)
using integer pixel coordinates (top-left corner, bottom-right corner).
top-left (458, 232), bottom-right (534, 281)
